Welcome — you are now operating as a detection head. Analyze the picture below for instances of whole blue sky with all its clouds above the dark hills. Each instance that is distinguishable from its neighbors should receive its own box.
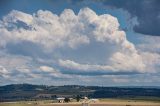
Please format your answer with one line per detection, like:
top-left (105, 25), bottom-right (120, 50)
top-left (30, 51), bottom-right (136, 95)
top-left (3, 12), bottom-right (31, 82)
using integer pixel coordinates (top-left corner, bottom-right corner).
top-left (0, 0), bottom-right (160, 86)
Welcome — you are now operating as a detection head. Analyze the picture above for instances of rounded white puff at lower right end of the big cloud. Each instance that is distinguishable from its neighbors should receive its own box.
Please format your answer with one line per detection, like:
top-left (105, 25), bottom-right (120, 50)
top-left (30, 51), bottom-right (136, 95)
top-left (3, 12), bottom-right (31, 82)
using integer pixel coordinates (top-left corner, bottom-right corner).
top-left (110, 52), bottom-right (146, 72)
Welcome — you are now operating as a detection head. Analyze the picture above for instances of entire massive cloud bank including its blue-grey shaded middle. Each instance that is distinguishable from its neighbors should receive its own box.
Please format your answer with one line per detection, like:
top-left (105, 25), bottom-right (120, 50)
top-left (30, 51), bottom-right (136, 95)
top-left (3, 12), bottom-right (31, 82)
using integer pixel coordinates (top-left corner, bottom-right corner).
top-left (0, 8), bottom-right (160, 85)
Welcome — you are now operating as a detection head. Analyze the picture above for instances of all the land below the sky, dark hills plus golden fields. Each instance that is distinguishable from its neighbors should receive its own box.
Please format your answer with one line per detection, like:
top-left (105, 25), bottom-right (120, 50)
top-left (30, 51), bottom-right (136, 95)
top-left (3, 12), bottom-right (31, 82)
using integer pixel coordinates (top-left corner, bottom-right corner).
top-left (0, 84), bottom-right (160, 106)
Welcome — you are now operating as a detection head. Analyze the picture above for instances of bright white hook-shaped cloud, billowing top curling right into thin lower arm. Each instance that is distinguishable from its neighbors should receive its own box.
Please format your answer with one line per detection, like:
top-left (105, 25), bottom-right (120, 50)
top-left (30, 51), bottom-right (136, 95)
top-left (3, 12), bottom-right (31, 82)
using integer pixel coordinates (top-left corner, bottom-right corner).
top-left (0, 8), bottom-right (149, 72)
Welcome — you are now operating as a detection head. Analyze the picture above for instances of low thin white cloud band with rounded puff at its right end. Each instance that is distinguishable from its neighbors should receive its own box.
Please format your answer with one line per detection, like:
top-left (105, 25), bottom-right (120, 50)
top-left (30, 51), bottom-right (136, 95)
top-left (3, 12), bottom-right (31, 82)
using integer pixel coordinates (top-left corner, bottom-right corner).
top-left (59, 52), bottom-right (146, 73)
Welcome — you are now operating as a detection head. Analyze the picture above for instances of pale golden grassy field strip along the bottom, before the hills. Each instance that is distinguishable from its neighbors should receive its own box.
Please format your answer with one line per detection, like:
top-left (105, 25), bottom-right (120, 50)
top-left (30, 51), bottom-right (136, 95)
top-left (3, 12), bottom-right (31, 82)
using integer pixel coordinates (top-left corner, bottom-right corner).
top-left (0, 99), bottom-right (160, 106)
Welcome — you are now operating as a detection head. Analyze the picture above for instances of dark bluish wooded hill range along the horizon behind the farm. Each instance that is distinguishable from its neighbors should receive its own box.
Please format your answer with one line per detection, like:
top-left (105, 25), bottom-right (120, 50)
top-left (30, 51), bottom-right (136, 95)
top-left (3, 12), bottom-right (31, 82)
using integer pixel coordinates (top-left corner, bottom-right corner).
top-left (0, 84), bottom-right (160, 101)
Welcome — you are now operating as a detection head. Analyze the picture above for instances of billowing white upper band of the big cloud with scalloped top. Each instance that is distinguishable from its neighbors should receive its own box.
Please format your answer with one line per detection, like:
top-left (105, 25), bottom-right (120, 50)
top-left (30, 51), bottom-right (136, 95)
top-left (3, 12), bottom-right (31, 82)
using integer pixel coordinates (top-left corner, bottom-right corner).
top-left (0, 8), bottom-right (133, 51)
